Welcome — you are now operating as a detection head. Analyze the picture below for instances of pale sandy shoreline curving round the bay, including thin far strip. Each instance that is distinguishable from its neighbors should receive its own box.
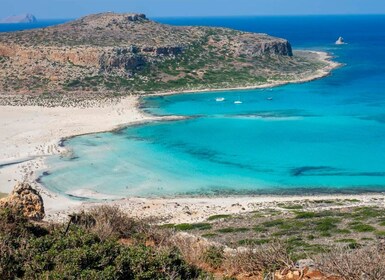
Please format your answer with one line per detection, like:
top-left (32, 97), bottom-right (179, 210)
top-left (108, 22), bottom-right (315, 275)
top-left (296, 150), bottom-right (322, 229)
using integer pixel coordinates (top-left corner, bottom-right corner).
top-left (0, 51), bottom-right (350, 220)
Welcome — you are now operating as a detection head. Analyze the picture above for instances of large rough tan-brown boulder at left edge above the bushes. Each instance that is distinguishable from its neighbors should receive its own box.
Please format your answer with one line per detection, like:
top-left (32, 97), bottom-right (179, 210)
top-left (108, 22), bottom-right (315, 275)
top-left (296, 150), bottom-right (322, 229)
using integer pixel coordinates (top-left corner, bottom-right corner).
top-left (0, 183), bottom-right (45, 221)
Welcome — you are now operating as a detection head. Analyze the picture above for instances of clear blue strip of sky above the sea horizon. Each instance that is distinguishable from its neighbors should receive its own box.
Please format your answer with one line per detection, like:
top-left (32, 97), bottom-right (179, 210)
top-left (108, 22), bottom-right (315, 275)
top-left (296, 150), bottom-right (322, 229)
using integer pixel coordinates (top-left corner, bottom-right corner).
top-left (0, 0), bottom-right (385, 19)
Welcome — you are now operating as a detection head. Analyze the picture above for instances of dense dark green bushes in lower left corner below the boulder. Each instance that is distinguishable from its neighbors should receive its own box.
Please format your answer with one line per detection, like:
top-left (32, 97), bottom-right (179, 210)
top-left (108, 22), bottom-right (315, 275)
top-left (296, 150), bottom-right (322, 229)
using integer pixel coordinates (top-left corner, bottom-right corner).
top-left (0, 208), bottom-right (205, 280)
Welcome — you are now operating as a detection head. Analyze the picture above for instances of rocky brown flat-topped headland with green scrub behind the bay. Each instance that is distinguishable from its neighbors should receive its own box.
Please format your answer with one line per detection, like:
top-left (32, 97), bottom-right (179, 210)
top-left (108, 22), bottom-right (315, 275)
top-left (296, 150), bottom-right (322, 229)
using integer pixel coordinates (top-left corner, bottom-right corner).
top-left (0, 13), bottom-right (325, 103)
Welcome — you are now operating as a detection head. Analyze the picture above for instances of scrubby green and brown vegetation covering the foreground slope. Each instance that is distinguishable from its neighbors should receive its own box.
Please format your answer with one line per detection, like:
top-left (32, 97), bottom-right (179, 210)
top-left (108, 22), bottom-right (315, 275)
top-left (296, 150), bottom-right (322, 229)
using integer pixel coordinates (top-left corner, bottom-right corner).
top-left (0, 202), bottom-right (385, 280)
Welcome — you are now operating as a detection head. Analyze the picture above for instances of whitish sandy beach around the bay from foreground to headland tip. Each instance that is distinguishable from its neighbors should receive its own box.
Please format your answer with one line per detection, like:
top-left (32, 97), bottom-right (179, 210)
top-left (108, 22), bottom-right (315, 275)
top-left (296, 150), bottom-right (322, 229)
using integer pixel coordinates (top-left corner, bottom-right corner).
top-left (0, 49), bottom-right (370, 223)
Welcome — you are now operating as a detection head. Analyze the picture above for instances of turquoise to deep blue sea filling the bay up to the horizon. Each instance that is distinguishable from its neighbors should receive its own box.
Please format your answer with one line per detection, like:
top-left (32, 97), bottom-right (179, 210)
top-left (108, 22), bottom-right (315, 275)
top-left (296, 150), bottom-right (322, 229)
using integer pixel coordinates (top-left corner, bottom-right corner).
top-left (41, 16), bottom-right (385, 197)
